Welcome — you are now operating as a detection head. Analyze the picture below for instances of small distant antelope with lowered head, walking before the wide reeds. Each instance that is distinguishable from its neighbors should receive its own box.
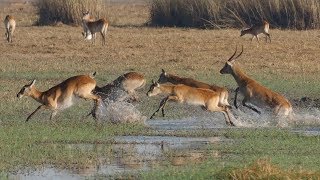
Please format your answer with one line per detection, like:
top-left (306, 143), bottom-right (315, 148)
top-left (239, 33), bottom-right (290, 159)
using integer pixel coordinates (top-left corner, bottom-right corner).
top-left (240, 21), bottom-right (271, 43)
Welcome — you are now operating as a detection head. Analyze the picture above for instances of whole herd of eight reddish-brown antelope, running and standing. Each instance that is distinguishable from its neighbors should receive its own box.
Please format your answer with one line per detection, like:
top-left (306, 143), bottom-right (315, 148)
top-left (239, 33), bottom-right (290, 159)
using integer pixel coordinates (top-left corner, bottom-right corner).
top-left (4, 12), bottom-right (293, 126)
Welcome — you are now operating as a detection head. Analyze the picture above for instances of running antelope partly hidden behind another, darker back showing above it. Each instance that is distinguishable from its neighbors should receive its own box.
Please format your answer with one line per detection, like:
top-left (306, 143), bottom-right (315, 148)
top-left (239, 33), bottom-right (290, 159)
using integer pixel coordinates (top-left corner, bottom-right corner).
top-left (158, 69), bottom-right (231, 108)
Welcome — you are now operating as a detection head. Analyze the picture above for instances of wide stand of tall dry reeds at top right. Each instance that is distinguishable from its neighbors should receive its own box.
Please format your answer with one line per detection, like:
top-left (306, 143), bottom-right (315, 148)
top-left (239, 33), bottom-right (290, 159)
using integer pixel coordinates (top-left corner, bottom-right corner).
top-left (150, 0), bottom-right (320, 29)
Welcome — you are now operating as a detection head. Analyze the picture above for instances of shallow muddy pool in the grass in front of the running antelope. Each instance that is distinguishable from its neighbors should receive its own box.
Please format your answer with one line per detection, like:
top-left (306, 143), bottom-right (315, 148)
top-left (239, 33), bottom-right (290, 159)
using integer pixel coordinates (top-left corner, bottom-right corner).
top-left (9, 136), bottom-right (226, 179)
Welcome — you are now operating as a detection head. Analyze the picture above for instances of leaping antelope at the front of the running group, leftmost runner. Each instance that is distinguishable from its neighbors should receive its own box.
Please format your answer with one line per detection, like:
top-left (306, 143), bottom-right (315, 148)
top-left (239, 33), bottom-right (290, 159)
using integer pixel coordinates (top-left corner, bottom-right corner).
top-left (17, 73), bottom-right (100, 122)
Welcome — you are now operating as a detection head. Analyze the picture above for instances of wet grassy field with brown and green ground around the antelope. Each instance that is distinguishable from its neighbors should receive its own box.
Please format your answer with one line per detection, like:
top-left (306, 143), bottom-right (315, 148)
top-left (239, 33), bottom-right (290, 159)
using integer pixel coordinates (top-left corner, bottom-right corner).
top-left (0, 0), bottom-right (320, 179)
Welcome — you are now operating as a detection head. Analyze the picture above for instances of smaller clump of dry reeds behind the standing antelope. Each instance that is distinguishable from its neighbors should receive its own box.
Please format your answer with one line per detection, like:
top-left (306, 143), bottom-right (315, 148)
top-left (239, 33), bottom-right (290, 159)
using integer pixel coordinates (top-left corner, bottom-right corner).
top-left (37, 0), bottom-right (105, 25)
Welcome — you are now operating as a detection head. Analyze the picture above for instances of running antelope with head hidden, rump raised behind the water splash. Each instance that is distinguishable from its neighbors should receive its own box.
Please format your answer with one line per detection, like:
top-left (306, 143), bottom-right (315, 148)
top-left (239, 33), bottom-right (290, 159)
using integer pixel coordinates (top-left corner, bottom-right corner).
top-left (95, 72), bottom-right (146, 101)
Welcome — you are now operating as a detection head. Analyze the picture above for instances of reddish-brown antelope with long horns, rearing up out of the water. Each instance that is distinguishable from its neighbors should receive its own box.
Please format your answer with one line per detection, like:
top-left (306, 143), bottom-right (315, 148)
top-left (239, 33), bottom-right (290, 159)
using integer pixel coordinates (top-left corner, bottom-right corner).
top-left (220, 46), bottom-right (292, 120)
